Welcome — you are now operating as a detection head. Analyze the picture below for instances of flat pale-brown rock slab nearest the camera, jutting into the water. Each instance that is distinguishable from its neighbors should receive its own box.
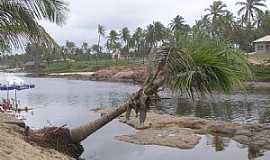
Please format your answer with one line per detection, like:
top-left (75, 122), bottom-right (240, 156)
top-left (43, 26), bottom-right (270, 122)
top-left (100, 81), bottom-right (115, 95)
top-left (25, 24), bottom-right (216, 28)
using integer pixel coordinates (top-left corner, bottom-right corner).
top-left (116, 128), bottom-right (201, 149)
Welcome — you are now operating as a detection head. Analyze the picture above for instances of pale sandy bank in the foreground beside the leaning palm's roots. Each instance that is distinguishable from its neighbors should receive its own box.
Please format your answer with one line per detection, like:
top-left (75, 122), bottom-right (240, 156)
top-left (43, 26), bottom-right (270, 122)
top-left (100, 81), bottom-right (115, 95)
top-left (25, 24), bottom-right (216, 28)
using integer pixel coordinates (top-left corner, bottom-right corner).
top-left (0, 113), bottom-right (73, 160)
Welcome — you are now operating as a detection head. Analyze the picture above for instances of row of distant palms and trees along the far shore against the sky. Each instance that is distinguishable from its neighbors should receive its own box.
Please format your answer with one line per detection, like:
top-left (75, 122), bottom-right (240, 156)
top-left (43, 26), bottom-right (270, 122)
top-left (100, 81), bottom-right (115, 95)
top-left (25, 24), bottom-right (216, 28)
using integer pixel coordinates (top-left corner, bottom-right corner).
top-left (1, 0), bottom-right (270, 66)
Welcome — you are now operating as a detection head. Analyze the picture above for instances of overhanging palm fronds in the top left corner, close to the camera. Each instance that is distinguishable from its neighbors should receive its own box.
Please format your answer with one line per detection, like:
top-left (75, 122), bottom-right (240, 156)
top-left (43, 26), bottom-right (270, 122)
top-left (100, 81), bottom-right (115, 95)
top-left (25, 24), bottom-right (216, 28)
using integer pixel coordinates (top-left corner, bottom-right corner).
top-left (0, 0), bottom-right (68, 47)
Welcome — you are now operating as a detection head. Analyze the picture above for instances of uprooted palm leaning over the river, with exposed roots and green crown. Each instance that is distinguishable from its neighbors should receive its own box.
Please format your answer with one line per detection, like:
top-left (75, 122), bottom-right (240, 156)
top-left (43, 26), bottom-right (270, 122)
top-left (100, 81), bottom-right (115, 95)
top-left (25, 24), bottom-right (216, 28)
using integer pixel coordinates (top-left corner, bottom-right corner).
top-left (26, 33), bottom-right (251, 158)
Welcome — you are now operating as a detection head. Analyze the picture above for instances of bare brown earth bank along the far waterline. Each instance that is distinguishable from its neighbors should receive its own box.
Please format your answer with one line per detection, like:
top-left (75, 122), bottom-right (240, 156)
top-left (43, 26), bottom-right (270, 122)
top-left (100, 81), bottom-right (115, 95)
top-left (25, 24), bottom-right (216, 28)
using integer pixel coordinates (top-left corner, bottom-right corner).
top-left (27, 66), bottom-right (270, 90)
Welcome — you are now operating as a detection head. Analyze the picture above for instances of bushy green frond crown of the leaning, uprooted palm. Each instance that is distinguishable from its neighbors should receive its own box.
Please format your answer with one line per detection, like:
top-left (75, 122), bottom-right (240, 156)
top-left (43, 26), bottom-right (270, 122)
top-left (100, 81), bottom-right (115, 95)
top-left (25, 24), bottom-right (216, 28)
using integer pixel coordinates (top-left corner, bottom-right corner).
top-left (152, 33), bottom-right (252, 97)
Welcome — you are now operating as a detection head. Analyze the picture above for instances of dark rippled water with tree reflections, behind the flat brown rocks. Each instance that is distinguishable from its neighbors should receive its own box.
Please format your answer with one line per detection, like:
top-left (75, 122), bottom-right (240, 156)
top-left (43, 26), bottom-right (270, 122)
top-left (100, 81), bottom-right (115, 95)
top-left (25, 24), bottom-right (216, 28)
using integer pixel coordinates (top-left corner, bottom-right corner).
top-left (158, 92), bottom-right (270, 123)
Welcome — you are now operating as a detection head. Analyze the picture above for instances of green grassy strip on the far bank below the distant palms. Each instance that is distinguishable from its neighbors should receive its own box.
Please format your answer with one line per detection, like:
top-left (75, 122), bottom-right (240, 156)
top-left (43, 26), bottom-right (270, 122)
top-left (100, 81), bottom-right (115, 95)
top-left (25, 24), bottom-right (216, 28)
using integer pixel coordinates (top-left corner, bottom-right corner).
top-left (41, 59), bottom-right (142, 73)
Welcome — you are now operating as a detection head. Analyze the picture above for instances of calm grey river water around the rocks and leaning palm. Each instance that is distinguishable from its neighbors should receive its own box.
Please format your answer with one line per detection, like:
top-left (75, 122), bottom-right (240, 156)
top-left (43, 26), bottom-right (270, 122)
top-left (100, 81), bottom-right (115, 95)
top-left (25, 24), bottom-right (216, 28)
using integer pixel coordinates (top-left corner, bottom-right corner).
top-left (0, 73), bottom-right (270, 160)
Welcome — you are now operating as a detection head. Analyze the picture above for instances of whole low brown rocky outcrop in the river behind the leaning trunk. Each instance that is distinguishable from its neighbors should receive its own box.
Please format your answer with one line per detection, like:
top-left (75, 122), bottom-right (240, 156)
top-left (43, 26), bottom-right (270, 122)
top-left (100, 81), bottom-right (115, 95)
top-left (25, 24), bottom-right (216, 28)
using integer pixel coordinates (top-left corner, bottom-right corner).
top-left (96, 109), bottom-right (270, 150)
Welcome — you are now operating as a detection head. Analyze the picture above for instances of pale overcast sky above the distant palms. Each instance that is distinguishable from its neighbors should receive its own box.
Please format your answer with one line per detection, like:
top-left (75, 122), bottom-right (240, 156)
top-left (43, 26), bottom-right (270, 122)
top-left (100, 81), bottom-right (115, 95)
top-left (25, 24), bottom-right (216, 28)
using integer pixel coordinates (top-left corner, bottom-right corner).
top-left (41, 0), bottom-right (270, 46)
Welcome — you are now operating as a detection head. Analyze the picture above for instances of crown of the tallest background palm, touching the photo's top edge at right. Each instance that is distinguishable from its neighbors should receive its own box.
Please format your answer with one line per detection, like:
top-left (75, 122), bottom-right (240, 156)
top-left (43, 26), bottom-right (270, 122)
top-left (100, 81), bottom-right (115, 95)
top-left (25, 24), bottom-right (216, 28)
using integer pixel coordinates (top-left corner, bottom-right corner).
top-left (236, 0), bottom-right (266, 25)
